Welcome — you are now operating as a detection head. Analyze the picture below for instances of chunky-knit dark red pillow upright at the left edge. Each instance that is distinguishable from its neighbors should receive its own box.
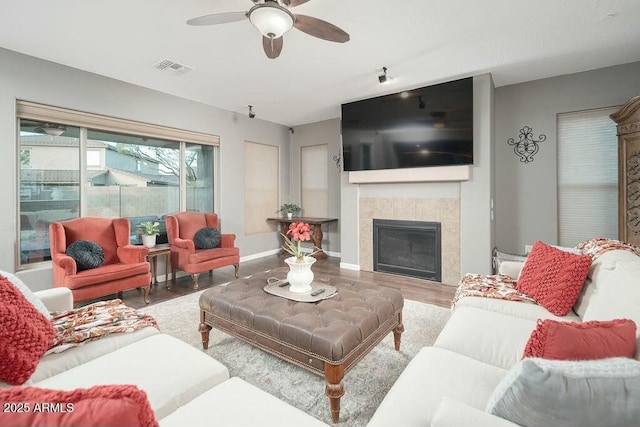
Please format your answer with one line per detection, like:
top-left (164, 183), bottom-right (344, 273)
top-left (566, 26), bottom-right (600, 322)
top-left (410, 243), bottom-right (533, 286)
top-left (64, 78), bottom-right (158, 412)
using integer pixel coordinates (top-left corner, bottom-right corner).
top-left (0, 277), bottom-right (56, 386)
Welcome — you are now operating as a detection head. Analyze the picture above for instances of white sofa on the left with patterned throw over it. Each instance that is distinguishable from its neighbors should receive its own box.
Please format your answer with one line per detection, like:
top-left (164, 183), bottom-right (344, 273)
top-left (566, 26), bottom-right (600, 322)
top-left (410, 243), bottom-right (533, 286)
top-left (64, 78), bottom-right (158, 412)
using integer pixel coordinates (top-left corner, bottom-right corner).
top-left (6, 288), bottom-right (326, 427)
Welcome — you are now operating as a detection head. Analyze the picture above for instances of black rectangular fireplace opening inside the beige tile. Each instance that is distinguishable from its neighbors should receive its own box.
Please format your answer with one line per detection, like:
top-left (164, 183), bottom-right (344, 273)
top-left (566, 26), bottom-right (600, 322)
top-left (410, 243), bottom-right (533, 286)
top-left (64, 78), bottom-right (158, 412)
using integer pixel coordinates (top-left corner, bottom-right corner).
top-left (373, 219), bottom-right (442, 282)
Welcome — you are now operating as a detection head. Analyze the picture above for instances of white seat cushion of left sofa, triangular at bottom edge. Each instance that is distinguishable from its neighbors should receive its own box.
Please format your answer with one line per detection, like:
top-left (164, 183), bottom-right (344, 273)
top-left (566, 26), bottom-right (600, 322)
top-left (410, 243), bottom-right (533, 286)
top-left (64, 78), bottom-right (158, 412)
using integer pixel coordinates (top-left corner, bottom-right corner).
top-left (162, 377), bottom-right (328, 427)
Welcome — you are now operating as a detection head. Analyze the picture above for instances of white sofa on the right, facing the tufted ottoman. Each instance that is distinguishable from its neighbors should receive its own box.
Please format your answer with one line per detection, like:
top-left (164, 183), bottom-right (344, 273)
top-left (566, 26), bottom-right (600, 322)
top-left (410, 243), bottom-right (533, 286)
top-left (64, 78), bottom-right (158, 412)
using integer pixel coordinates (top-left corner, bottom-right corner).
top-left (368, 250), bottom-right (640, 427)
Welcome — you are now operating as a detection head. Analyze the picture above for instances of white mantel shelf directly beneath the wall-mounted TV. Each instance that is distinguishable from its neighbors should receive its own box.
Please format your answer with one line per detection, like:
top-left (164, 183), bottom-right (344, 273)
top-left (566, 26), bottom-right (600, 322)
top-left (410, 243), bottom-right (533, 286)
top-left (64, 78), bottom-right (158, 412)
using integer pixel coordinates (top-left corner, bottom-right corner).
top-left (349, 165), bottom-right (471, 184)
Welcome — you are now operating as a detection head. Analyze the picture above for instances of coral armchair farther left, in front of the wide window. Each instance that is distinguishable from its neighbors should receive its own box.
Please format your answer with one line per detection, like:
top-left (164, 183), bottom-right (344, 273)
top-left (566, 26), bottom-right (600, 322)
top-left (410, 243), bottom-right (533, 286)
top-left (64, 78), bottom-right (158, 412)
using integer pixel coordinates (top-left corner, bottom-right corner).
top-left (49, 217), bottom-right (151, 304)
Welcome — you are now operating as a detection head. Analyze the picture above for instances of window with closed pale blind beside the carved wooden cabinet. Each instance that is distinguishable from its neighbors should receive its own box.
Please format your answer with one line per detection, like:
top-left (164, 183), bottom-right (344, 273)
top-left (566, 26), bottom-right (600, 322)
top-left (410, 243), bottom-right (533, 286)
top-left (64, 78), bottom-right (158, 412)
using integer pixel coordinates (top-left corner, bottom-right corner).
top-left (558, 108), bottom-right (618, 246)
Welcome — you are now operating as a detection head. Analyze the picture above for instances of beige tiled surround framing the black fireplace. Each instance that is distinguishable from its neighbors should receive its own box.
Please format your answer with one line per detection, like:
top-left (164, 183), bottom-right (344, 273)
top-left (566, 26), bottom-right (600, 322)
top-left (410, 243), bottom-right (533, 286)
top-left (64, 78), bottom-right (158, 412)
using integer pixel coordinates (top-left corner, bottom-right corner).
top-left (358, 197), bottom-right (460, 285)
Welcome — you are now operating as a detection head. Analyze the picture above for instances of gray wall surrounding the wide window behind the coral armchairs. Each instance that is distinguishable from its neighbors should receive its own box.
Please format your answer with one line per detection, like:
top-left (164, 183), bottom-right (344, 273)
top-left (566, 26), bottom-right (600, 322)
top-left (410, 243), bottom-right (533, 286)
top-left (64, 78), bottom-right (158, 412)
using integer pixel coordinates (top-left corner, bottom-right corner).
top-left (0, 49), bottom-right (291, 290)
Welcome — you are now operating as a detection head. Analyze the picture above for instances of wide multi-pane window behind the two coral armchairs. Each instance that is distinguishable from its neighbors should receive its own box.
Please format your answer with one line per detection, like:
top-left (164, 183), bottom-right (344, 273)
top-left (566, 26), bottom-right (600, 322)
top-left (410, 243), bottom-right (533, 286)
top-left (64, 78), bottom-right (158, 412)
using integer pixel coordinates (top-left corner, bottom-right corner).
top-left (17, 101), bottom-right (218, 266)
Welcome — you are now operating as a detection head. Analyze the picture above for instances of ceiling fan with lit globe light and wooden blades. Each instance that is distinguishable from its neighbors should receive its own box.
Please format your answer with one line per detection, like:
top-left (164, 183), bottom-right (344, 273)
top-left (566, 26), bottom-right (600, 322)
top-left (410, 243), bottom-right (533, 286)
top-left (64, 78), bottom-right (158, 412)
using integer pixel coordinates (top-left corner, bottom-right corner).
top-left (187, 0), bottom-right (349, 59)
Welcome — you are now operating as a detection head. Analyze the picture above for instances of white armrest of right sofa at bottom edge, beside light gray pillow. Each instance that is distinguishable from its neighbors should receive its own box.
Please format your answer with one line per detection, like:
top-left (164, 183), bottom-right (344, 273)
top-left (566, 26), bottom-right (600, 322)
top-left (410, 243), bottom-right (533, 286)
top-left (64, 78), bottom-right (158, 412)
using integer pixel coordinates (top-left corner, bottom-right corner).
top-left (431, 397), bottom-right (519, 427)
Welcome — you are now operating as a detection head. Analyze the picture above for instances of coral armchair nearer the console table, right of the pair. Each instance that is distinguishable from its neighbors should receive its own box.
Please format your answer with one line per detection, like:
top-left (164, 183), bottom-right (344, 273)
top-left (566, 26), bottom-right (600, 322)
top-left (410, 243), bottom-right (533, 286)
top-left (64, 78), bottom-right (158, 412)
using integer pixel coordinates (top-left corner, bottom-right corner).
top-left (165, 212), bottom-right (240, 289)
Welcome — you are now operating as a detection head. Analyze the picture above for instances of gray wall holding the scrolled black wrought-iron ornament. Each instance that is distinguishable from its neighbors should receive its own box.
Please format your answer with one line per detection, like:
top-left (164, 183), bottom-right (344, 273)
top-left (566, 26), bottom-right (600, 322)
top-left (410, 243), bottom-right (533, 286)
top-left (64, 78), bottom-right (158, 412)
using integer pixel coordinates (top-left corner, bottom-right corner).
top-left (494, 62), bottom-right (640, 253)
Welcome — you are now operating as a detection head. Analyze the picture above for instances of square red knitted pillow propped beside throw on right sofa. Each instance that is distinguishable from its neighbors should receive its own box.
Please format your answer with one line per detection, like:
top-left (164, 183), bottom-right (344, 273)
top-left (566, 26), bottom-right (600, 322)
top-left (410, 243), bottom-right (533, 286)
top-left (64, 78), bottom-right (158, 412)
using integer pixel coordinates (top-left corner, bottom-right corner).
top-left (516, 241), bottom-right (591, 316)
